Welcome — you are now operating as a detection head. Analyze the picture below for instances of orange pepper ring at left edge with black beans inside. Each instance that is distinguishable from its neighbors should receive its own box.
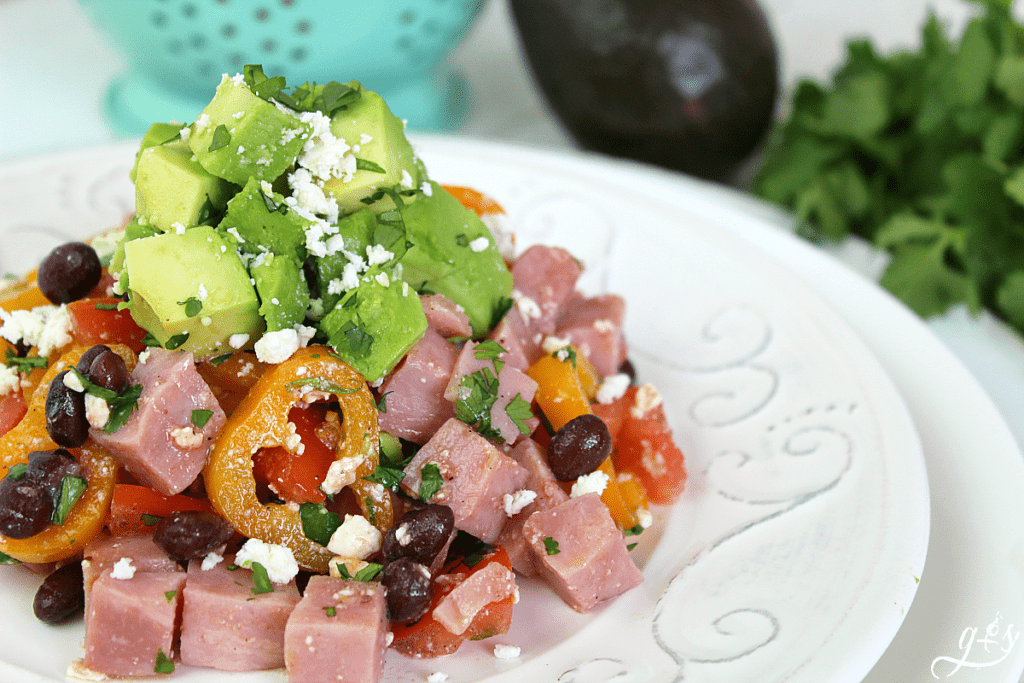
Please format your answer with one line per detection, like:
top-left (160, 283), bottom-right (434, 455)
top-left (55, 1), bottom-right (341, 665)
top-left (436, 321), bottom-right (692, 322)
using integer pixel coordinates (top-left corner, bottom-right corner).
top-left (0, 344), bottom-right (129, 562)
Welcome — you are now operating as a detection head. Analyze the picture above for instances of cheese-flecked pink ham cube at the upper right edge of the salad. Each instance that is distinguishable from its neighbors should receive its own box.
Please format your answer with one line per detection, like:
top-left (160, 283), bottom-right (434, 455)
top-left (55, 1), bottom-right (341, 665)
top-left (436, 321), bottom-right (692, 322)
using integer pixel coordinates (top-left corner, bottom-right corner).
top-left (555, 294), bottom-right (626, 377)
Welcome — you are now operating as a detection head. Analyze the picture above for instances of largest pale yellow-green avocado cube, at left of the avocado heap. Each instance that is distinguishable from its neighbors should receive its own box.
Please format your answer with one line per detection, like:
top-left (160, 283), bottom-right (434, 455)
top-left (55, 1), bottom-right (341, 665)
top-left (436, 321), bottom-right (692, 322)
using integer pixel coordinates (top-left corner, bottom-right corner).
top-left (124, 225), bottom-right (263, 357)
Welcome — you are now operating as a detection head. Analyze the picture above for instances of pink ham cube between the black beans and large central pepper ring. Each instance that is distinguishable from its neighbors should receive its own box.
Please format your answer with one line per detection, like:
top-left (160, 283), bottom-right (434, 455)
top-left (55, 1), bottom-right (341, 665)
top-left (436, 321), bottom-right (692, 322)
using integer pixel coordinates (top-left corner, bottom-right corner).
top-left (89, 348), bottom-right (225, 495)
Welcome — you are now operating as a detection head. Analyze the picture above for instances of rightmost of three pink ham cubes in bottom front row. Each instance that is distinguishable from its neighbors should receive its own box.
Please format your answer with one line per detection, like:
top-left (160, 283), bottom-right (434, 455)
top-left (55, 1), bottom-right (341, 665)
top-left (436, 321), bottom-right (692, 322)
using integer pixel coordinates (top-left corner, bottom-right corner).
top-left (285, 575), bottom-right (388, 683)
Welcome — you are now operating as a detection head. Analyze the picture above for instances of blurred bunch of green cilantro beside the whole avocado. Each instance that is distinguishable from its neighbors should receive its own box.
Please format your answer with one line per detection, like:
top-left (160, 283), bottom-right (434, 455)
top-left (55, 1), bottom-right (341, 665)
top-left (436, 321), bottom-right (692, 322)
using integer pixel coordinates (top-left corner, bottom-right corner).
top-left (754, 0), bottom-right (1024, 333)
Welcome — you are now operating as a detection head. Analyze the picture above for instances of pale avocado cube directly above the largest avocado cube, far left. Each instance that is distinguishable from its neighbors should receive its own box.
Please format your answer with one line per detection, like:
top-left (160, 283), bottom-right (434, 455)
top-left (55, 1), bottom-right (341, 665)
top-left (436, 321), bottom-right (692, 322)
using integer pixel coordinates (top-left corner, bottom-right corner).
top-left (135, 140), bottom-right (234, 232)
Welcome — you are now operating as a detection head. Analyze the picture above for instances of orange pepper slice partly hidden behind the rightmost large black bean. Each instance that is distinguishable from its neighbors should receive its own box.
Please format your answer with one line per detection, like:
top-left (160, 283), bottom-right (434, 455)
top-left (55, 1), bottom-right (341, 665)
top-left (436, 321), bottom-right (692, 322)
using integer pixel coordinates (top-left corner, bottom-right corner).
top-left (526, 353), bottom-right (637, 528)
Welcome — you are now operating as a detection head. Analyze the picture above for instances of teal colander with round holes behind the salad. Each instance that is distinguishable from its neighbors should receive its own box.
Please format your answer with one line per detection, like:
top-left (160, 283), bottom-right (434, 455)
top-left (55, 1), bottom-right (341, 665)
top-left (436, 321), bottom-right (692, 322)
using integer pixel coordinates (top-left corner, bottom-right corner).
top-left (80, 0), bottom-right (484, 135)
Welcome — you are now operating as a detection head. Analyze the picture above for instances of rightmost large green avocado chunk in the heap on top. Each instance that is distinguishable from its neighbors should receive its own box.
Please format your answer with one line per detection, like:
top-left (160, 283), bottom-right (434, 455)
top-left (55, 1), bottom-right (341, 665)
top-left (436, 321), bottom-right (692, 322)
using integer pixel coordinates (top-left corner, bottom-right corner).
top-left (401, 182), bottom-right (512, 337)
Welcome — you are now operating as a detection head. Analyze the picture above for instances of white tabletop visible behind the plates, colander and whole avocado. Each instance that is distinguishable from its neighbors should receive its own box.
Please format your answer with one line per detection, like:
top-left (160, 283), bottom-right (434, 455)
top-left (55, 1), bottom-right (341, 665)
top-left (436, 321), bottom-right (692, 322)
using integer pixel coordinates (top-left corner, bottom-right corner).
top-left (0, 0), bottom-right (1024, 680)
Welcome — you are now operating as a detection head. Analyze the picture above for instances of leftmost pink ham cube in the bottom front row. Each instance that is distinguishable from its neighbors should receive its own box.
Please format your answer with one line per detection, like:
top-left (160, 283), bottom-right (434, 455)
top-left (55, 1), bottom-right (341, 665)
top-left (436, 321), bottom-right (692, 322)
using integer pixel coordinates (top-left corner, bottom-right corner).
top-left (82, 569), bottom-right (185, 676)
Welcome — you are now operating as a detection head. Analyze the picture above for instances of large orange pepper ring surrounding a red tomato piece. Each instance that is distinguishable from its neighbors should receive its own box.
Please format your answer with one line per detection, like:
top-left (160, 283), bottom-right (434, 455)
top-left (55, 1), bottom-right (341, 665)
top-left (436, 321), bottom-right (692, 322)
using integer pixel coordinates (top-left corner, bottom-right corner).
top-left (203, 346), bottom-right (393, 573)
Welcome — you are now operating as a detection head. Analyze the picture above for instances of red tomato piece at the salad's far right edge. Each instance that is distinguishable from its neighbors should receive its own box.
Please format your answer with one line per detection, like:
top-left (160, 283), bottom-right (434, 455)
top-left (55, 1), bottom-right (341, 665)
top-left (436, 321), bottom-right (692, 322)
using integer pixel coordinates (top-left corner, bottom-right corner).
top-left (612, 387), bottom-right (686, 505)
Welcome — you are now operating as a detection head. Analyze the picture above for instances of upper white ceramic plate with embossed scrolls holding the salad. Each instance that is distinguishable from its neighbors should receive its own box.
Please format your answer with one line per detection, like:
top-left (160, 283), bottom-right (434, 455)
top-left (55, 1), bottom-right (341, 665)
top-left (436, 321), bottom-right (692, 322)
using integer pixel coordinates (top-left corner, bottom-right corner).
top-left (0, 137), bottom-right (930, 683)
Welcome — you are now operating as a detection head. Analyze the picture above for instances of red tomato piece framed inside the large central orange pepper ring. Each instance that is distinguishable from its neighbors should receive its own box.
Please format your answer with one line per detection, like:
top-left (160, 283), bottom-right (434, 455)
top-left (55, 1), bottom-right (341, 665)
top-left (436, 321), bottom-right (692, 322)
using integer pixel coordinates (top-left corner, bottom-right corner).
top-left (253, 404), bottom-right (335, 503)
